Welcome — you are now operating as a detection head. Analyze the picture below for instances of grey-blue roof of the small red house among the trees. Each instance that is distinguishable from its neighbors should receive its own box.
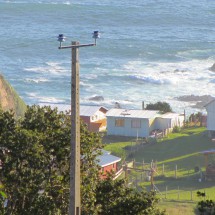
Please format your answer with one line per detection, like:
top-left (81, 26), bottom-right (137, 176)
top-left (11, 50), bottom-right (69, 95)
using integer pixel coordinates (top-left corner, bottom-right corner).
top-left (97, 150), bottom-right (121, 167)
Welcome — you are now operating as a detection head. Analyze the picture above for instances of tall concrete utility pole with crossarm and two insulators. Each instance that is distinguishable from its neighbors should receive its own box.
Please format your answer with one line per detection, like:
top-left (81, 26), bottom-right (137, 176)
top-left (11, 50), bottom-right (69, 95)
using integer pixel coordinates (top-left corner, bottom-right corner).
top-left (58, 31), bottom-right (100, 215)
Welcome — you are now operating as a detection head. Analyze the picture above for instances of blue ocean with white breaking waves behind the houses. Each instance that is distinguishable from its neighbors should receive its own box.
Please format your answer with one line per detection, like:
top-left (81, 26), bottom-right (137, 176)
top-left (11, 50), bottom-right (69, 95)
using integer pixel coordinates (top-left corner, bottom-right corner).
top-left (0, 0), bottom-right (215, 113)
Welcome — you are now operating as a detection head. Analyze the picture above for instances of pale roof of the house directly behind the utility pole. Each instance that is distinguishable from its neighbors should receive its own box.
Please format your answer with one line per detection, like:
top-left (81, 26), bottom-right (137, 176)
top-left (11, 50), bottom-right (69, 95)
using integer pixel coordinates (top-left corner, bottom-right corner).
top-left (38, 104), bottom-right (108, 116)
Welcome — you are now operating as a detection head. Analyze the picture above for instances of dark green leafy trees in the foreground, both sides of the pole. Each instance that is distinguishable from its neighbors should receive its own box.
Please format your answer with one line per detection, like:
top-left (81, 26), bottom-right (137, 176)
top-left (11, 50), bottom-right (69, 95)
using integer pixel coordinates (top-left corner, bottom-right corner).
top-left (0, 106), bottom-right (164, 215)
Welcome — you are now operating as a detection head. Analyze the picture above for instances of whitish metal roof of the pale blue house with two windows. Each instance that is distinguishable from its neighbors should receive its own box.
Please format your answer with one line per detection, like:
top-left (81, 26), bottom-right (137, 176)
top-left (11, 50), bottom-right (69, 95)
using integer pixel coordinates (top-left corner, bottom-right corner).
top-left (106, 108), bottom-right (160, 119)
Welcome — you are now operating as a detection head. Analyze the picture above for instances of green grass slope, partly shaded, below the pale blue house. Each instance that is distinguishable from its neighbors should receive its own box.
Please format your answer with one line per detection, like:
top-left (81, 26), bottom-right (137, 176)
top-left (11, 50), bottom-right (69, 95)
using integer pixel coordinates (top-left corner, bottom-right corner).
top-left (105, 127), bottom-right (215, 214)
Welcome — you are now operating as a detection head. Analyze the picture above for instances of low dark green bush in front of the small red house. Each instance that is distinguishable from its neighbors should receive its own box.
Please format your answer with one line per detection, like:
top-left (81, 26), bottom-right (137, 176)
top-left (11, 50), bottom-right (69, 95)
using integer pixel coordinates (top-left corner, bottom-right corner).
top-left (96, 177), bottom-right (165, 215)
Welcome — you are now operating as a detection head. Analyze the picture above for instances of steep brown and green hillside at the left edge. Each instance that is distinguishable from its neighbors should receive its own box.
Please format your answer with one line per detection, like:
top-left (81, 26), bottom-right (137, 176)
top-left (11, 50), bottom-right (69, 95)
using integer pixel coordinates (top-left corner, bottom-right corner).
top-left (0, 75), bottom-right (26, 117)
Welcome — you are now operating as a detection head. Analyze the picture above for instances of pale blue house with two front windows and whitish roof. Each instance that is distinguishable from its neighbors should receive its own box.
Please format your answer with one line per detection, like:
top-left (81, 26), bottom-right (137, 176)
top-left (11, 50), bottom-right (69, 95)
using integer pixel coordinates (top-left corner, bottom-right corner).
top-left (106, 108), bottom-right (184, 137)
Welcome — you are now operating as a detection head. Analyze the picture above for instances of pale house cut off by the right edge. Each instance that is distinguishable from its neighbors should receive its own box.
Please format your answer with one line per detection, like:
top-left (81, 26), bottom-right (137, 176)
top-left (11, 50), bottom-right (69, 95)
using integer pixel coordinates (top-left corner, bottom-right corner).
top-left (205, 99), bottom-right (215, 131)
